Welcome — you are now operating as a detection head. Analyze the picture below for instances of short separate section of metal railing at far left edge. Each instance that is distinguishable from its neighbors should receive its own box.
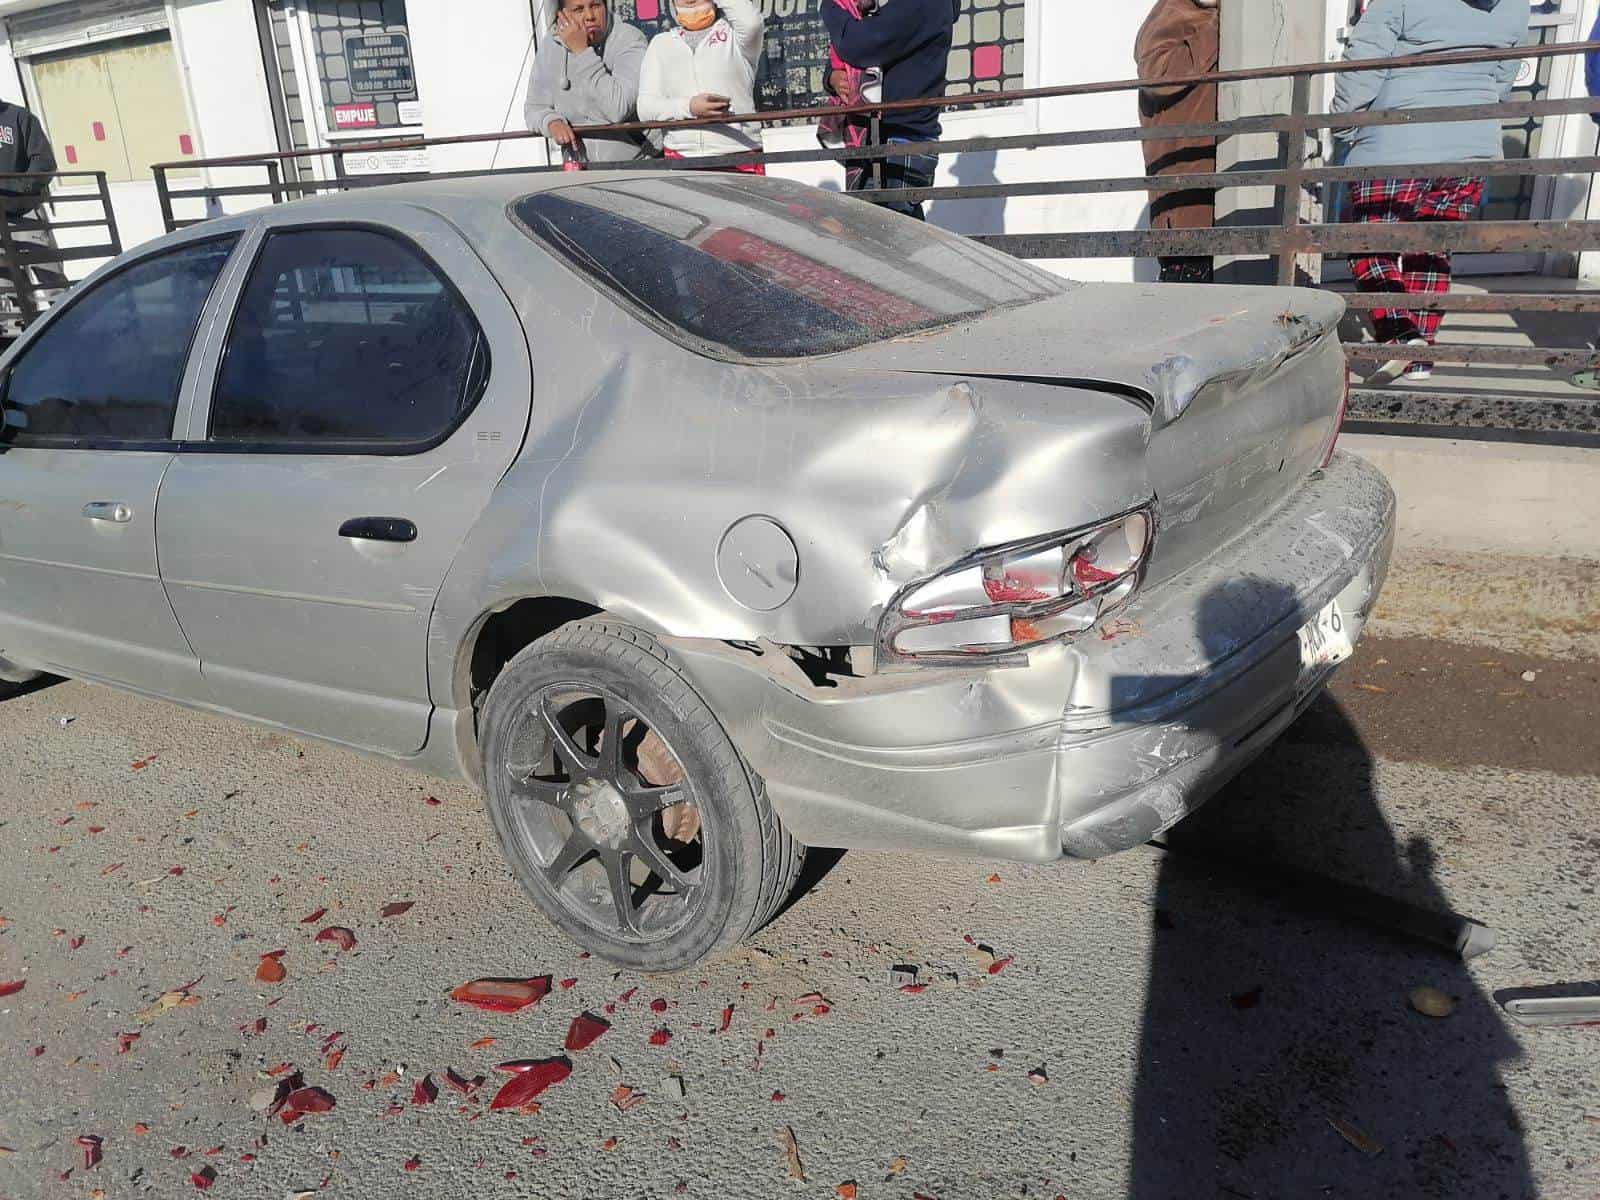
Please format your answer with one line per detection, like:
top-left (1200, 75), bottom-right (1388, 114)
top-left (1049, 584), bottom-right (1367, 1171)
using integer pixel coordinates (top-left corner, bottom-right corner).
top-left (0, 171), bottom-right (122, 336)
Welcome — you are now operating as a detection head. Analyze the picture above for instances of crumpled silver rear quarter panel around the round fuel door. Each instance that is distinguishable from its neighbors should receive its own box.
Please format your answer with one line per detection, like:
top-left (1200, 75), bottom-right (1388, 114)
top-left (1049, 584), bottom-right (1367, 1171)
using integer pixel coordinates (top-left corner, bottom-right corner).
top-left (432, 191), bottom-right (1152, 706)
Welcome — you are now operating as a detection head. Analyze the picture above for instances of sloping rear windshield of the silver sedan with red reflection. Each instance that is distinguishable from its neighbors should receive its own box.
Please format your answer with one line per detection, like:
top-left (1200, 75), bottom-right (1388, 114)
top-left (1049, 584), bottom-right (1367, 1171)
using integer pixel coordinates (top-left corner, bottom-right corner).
top-left (514, 174), bottom-right (1064, 358)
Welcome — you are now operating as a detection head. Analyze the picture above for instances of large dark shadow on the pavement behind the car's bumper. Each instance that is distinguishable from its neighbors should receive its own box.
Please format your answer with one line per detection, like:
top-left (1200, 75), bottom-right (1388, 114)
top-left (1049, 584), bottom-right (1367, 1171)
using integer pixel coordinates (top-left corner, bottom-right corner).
top-left (1128, 594), bottom-right (1533, 1200)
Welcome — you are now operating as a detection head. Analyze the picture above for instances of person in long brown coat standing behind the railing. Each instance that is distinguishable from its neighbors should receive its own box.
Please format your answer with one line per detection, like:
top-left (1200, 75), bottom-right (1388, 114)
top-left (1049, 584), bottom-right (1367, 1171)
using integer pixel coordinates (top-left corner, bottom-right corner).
top-left (1134, 0), bottom-right (1221, 283)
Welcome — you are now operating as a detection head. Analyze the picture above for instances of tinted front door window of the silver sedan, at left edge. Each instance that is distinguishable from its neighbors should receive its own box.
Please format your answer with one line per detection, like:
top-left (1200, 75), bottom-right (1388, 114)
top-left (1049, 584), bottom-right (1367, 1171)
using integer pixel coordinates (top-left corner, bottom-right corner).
top-left (5, 235), bottom-right (238, 446)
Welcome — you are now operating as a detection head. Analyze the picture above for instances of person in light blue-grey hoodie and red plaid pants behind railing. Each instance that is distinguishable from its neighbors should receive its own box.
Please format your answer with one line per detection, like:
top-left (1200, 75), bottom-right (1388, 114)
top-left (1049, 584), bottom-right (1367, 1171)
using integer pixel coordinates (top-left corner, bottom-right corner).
top-left (1333, 0), bottom-right (1530, 381)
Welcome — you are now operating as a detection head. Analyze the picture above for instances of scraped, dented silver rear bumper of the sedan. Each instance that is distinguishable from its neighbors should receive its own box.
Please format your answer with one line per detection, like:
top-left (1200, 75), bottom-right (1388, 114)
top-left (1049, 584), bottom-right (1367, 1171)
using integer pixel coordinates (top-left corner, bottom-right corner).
top-left (674, 454), bottom-right (1395, 862)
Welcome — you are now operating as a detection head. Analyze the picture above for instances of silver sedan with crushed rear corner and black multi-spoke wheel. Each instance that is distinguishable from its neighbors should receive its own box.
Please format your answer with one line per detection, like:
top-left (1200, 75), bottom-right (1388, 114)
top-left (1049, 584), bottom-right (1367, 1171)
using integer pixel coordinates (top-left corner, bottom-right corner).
top-left (0, 173), bottom-right (1395, 970)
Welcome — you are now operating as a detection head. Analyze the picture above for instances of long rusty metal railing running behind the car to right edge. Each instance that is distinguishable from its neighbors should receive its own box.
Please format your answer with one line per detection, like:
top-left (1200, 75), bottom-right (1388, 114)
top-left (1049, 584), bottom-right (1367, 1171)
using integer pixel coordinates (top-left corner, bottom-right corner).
top-left (154, 42), bottom-right (1600, 445)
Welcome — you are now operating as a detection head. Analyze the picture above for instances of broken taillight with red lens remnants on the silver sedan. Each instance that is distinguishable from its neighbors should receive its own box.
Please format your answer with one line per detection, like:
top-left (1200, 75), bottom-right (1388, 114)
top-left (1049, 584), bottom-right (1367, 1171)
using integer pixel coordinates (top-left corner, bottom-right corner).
top-left (877, 507), bottom-right (1155, 666)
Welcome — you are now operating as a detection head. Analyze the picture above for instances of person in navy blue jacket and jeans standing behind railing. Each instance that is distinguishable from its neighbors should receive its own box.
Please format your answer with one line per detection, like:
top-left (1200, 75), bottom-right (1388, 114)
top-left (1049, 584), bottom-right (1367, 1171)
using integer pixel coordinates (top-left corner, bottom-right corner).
top-left (822, 0), bottom-right (960, 221)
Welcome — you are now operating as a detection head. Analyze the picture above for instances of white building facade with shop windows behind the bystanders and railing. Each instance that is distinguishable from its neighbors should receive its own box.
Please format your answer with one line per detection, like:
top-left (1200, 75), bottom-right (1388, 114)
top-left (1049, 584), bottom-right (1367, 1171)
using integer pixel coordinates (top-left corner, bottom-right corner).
top-left (0, 0), bottom-right (1600, 278)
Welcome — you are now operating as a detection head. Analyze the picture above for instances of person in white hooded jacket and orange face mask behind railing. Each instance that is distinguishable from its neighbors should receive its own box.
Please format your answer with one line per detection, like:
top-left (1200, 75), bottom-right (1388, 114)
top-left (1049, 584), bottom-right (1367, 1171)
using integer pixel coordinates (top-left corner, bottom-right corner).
top-left (638, 0), bottom-right (765, 173)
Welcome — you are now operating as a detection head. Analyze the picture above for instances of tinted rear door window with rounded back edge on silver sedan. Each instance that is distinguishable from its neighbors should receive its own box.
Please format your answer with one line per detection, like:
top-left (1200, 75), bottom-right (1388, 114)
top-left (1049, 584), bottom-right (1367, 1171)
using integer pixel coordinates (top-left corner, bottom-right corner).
top-left (211, 227), bottom-right (488, 451)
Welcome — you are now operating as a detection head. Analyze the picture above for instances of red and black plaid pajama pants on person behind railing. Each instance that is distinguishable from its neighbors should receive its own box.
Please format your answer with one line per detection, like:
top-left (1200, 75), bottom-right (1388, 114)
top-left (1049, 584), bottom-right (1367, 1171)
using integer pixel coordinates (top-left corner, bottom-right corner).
top-left (1350, 179), bottom-right (1483, 344)
